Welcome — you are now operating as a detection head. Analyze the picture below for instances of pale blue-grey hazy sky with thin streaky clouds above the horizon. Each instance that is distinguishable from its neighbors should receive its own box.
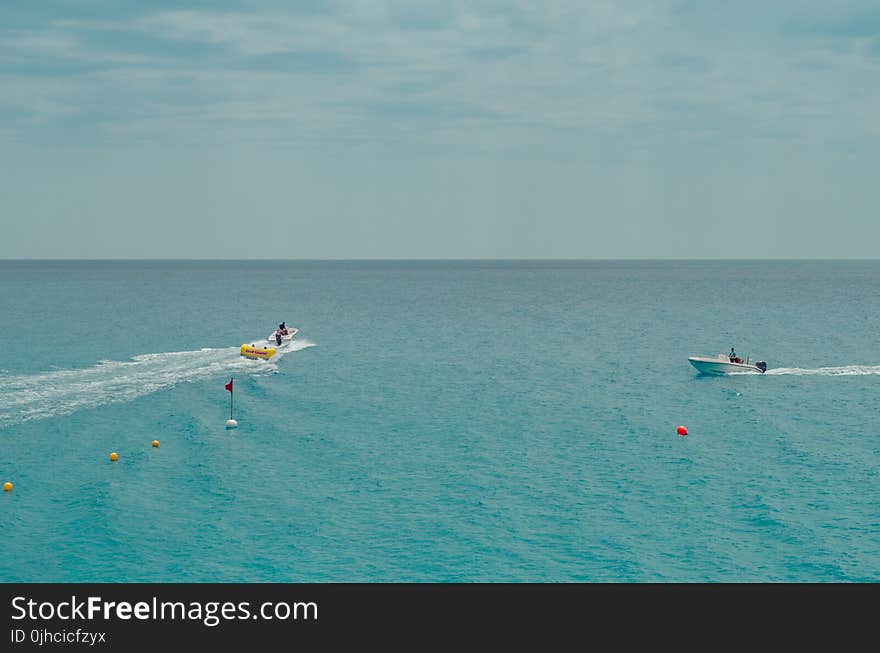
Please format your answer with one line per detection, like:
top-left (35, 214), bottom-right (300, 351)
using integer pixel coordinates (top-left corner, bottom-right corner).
top-left (0, 0), bottom-right (880, 259)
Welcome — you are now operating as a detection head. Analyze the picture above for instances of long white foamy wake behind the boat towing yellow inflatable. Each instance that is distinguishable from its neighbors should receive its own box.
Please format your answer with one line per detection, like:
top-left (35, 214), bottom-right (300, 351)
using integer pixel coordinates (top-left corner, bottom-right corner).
top-left (0, 340), bottom-right (314, 429)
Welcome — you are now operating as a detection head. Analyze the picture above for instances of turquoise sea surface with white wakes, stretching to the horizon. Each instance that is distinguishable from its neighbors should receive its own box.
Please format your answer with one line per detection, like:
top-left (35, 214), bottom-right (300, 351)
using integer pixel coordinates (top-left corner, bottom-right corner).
top-left (0, 261), bottom-right (880, 582)
